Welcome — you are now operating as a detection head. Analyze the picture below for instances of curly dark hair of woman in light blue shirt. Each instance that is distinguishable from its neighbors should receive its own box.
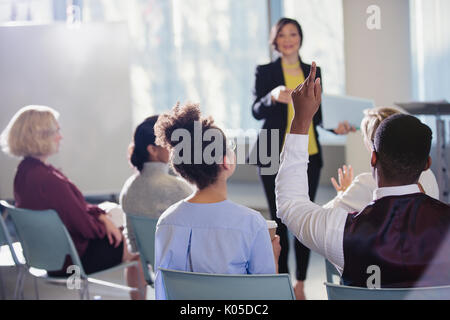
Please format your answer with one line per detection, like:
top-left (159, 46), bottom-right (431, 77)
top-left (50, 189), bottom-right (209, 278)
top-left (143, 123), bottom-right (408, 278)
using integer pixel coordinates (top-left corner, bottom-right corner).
top-left (155, 104), bottom-right (226, 190)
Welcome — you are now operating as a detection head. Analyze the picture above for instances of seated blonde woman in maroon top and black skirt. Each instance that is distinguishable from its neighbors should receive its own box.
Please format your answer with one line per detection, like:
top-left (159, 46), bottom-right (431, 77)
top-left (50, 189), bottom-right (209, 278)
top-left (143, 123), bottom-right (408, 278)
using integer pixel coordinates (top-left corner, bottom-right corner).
top-left (2, 106), bottom-right (145, 299)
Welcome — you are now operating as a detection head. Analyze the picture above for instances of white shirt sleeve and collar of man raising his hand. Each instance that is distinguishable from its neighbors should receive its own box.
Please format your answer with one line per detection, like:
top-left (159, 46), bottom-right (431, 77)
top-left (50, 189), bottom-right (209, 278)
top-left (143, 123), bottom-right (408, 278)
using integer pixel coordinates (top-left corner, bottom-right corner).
top-left (275, 134), bottom-right (420, 274)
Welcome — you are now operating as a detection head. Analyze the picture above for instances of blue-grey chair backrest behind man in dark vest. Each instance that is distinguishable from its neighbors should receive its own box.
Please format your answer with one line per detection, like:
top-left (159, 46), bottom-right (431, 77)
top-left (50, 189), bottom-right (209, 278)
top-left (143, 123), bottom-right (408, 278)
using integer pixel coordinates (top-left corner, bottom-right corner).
top-left (325, 283), bottom-right (450, 300)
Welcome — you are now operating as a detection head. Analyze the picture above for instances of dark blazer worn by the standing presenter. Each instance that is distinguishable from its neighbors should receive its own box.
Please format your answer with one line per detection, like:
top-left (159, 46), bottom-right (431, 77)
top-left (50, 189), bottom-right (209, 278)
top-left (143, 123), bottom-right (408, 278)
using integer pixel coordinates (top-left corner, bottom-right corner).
top-left (251, 58), bottom-right (323, 167)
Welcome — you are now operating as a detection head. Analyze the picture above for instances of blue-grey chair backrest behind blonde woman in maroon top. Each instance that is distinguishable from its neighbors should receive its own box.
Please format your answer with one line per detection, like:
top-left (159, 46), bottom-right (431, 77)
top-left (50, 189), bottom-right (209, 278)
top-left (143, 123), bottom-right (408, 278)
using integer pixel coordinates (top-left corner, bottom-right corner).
top-left (2, 202), bottom-right (85, 276)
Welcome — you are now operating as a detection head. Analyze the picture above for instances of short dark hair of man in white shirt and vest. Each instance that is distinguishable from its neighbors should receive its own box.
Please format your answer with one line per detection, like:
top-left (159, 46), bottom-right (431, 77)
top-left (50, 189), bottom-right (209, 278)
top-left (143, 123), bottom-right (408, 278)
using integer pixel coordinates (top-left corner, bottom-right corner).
top-left (374, 114), bottom-right (433, 184)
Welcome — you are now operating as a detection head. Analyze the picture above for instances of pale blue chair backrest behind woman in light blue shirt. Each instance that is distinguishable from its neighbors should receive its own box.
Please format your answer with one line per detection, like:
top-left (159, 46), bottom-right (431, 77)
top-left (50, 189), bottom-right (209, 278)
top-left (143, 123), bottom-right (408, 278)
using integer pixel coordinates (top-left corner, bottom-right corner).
top-left (159, 268), bottom-right (295, 300)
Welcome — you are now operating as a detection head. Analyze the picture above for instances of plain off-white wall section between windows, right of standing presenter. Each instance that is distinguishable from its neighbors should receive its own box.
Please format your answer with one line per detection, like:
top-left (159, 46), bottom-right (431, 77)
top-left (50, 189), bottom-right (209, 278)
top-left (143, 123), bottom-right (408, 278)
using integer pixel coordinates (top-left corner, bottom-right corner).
top-left (343, 0), bottom-right (413, 173)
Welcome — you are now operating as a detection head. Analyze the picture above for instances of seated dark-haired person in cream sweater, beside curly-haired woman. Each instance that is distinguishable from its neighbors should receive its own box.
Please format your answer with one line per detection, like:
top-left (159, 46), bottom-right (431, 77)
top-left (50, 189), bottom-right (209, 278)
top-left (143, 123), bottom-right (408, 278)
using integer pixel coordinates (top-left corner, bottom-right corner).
top-left (120, 116), bottom-right (193, 252)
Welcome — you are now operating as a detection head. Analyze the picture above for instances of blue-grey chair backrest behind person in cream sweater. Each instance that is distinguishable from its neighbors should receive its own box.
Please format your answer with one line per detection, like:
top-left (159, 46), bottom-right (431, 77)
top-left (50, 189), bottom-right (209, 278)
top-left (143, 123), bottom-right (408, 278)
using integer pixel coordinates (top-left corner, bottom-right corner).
top-left (127, 214), bottom-right (158, 283)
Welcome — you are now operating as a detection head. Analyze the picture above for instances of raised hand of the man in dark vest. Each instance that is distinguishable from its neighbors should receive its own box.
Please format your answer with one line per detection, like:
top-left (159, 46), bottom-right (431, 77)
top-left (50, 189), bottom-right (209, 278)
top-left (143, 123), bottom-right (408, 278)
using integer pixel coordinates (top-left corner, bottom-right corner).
top-left (291, 62), bottom-right (322, 134)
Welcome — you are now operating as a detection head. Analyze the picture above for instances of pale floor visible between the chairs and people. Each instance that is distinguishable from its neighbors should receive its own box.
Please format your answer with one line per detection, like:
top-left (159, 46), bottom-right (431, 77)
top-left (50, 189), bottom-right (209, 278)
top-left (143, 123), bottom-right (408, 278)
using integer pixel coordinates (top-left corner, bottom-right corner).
top-left (0, 183), bottom-right (335, 300)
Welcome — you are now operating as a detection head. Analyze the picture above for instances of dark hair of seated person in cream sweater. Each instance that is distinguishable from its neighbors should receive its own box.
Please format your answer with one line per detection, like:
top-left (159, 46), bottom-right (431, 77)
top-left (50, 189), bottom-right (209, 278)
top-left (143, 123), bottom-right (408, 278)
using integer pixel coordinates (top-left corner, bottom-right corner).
top-left (130, 116), bottom-right (158, 171)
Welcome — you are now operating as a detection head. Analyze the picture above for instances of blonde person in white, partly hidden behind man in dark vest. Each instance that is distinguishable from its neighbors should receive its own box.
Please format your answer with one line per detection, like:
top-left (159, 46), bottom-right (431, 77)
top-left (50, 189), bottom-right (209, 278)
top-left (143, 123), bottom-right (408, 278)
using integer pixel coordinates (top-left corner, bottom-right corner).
top-left (323, 107), bottom-right (439, 212)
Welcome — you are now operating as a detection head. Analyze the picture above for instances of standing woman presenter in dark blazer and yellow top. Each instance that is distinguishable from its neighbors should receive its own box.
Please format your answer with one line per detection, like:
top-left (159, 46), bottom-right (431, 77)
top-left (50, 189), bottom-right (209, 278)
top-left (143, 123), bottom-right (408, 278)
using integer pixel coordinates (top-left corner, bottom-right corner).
top-left (252, 18), bottom-right (354, 300)
